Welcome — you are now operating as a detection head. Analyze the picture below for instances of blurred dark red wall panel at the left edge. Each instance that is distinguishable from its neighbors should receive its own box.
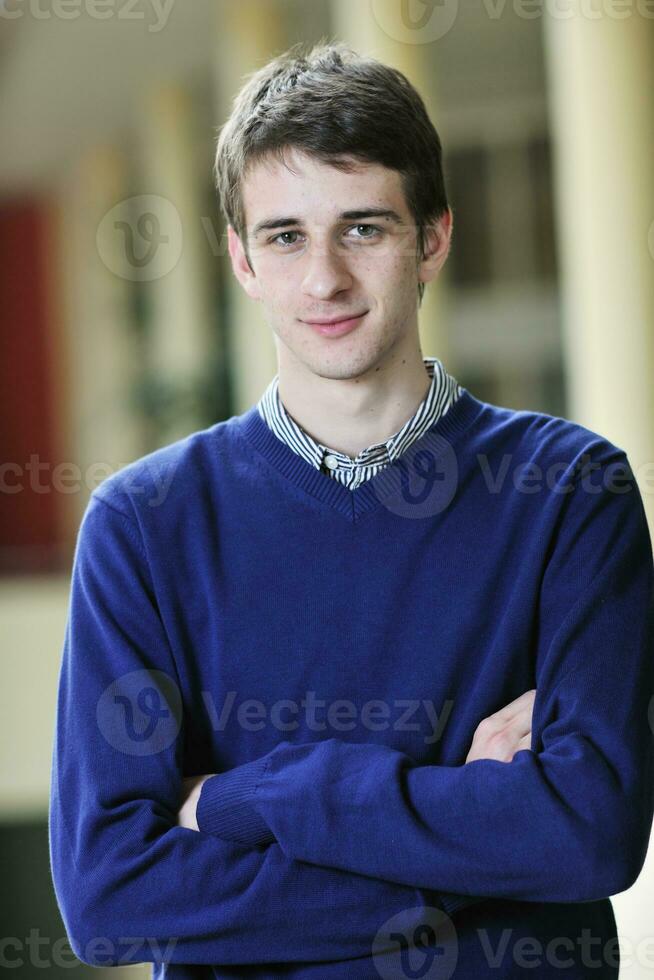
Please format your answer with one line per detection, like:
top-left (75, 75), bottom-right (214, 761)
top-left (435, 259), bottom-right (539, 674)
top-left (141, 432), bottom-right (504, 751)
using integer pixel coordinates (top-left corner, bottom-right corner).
top-left (0, 201), bottom-right (61, 574)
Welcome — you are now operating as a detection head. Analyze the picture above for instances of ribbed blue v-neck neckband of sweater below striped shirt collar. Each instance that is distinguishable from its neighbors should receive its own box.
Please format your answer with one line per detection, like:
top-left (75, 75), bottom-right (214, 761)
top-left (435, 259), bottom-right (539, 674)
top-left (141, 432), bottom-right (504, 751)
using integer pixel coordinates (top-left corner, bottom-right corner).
top-left (233, 388), bottom-right (484, 523)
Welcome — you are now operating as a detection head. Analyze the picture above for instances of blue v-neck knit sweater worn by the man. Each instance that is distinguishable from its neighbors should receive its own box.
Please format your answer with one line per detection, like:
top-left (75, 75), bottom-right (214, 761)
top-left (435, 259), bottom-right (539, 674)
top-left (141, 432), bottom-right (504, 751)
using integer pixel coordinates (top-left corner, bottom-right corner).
top-left (49, 389), bottom-right (654, 980)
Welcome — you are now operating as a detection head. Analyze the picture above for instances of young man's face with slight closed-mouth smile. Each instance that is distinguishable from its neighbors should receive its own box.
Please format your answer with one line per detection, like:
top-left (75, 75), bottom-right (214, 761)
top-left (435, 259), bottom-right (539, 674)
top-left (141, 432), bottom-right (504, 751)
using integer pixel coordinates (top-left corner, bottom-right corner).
top-left (228, 150), bottom-right (449, 379)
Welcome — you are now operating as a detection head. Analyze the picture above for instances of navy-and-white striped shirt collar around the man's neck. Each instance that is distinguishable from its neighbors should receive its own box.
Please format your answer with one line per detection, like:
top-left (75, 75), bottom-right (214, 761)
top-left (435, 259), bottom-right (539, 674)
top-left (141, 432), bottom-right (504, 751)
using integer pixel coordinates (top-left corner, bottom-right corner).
top-left (257, 357), bottom-right (463, 490)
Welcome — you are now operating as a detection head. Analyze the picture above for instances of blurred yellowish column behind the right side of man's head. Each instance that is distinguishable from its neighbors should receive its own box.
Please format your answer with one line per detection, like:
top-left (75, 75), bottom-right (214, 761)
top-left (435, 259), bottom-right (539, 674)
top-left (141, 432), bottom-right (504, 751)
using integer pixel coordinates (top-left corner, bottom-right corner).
top-left (332, 0), bottom-right (455, 373)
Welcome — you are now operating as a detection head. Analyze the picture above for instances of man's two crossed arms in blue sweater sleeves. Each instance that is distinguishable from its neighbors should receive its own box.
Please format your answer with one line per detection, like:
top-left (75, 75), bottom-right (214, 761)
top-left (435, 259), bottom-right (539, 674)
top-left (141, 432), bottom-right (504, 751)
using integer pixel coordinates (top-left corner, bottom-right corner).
top-left (50, 448), bottom-right (654, 965)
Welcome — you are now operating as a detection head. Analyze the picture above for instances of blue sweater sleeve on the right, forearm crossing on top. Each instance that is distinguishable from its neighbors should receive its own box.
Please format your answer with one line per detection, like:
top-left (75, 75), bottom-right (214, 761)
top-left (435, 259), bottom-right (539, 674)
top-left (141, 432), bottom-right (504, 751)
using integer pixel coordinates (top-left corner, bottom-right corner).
top-left (203, 444), bottom-right (654, 902)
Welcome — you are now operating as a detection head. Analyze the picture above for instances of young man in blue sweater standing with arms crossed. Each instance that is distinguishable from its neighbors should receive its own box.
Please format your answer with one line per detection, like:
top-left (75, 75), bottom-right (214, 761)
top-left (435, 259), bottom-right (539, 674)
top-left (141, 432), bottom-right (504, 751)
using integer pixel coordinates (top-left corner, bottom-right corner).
top-left (50, 45), bottom-right (654, 980)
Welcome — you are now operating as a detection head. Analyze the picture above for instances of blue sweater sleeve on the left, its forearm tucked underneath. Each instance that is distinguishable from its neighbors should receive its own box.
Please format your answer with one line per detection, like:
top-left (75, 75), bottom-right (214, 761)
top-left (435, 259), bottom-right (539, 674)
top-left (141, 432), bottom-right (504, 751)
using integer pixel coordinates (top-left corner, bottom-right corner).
top-left (48, 495), bottom-right (452, 966)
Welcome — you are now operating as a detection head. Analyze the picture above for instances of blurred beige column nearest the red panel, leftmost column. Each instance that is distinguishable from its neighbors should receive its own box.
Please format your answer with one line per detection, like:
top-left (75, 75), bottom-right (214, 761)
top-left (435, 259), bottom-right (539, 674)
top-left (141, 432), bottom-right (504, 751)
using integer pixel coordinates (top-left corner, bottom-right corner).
top-left (57, 147), bottom-right (142, 524)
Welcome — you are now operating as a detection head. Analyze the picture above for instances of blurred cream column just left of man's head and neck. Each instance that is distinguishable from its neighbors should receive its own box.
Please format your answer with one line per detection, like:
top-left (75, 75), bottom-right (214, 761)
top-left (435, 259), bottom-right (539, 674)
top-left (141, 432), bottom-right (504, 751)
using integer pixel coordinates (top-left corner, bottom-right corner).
top-left (214, 0), bottom-right (288, 413)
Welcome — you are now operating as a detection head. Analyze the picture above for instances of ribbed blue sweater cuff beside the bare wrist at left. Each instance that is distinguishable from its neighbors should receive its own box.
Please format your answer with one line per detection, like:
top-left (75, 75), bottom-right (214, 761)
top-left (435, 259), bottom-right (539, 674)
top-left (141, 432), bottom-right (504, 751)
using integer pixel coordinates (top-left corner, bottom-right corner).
top-left (196, 756), bottom-right (275, 846)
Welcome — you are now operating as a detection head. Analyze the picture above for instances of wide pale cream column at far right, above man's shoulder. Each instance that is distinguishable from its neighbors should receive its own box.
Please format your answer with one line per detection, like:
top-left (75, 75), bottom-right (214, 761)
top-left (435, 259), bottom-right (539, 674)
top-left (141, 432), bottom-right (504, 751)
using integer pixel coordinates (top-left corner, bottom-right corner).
top-left (544, 4), bottom-right (654, 527)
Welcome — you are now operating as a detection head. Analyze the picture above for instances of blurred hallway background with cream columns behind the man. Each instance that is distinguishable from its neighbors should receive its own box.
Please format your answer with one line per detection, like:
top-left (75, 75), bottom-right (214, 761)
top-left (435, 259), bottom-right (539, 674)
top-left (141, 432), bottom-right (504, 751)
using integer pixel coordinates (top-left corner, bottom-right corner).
top-left (0, 0), bottom-right (654, 980)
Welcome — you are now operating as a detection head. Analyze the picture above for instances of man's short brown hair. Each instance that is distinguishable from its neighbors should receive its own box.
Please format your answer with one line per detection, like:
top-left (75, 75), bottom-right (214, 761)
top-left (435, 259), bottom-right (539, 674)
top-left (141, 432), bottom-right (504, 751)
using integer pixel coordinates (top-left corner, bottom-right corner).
top-left (214, 39), bottom-right (448, 301)
